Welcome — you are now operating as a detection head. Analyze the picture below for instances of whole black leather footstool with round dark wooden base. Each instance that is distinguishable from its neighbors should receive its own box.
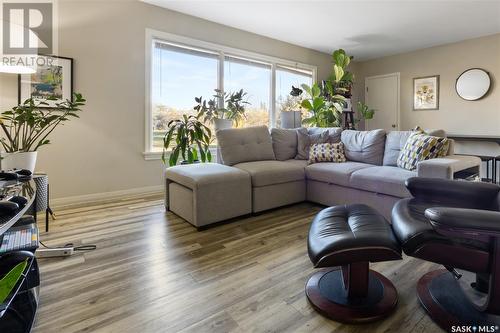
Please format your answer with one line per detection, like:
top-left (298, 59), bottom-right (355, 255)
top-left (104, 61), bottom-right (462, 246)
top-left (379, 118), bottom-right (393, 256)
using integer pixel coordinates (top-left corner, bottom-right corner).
top-left (306, 205), bottom-right (401, 323)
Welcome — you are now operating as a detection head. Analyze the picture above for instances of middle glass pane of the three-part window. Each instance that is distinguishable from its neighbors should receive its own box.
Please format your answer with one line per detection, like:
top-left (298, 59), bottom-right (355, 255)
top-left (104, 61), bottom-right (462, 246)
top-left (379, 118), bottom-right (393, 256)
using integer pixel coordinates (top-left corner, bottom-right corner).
top-left (224, 56), bottom-right (271, 127)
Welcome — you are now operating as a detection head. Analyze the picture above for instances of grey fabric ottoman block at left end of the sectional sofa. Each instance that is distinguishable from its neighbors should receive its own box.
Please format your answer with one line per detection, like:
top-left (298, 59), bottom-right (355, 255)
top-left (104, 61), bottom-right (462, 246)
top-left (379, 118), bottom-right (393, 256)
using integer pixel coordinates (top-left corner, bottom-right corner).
top-left (165, 163), bottom-right (252, 228)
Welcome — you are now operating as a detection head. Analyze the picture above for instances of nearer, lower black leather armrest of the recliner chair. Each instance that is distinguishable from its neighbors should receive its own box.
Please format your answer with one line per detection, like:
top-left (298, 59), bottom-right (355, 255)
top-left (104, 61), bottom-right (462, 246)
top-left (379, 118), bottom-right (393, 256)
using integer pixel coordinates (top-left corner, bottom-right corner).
top-left (425, 207), bottom-right (500, 236)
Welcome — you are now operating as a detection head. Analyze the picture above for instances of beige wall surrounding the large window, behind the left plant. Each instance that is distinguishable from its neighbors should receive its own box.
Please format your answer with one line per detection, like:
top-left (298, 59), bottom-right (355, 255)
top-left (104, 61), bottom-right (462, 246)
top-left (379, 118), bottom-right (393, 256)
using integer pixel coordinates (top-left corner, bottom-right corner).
top-left (0, 1), bottom-right (336, 198)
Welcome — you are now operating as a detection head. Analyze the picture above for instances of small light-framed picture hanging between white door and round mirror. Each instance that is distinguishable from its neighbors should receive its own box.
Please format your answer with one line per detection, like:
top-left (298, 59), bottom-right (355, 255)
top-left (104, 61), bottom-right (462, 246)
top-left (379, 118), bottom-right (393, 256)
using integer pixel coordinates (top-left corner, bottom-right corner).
top-left (413, 75), bottom-right (439, 111)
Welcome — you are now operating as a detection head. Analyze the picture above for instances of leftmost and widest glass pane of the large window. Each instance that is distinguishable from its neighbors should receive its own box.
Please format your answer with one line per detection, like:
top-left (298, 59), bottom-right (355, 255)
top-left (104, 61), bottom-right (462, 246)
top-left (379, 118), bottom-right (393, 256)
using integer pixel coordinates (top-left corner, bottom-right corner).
top-left (151, 42), bottom-right (218, 151)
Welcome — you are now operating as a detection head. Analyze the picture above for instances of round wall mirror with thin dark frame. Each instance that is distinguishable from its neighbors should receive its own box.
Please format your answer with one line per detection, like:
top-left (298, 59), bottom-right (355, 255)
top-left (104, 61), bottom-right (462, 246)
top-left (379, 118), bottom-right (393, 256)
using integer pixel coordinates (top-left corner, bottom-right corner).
top-left (455, 68), bottom-right (491, 101)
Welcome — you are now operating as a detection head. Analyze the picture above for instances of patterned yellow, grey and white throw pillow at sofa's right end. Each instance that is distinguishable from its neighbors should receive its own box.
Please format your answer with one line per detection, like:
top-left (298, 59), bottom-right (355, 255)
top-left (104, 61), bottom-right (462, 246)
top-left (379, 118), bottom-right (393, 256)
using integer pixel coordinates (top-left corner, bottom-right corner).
top-left (397, 127), bottom-right (450, 171)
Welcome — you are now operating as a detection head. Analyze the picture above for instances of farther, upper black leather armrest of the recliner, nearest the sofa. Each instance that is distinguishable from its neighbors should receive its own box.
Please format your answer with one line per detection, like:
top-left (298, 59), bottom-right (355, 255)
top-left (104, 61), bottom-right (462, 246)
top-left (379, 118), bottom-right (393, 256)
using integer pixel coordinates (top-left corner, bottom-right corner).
top-left (406, 177), bottom-right (500, 209)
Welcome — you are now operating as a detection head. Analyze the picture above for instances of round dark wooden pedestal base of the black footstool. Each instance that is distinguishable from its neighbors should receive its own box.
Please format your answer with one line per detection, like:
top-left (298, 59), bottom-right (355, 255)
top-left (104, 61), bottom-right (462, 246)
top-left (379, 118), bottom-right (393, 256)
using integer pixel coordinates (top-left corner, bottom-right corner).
top-left (306, 263), bottom-right (398, 324)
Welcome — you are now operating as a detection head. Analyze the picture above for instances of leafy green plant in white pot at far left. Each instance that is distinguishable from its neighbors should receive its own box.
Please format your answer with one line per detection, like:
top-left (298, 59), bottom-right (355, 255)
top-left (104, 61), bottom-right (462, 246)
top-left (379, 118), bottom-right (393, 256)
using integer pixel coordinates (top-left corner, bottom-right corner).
top-left (0, 93), bottom-right (86, 172)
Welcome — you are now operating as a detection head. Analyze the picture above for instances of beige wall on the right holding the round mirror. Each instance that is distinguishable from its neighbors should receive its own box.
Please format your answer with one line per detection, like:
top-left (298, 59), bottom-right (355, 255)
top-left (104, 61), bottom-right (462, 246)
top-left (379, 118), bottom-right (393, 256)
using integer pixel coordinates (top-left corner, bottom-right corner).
top-left (356, 34), bottom-right (500, 135)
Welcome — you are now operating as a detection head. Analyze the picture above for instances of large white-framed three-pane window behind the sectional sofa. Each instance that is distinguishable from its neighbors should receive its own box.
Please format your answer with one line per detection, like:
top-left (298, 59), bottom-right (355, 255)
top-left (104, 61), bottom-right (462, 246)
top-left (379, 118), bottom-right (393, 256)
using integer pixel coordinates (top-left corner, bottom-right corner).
top-left (145, 30), bottom-right (315, 158)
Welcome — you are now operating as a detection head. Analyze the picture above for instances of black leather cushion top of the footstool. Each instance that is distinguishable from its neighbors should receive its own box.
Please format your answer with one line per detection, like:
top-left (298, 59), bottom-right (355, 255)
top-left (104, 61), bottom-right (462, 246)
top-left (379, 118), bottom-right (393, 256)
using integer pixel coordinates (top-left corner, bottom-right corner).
top-left (308, 204), bottom-right (401, 267)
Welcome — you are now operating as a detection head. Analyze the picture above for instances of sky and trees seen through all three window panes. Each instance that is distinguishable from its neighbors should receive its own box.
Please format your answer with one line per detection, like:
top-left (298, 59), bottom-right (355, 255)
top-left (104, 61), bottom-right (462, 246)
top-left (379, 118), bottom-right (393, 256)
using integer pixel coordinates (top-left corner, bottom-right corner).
top-left (151, 41), bottom-right (312, 151)
